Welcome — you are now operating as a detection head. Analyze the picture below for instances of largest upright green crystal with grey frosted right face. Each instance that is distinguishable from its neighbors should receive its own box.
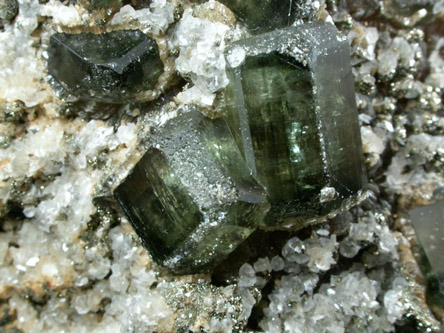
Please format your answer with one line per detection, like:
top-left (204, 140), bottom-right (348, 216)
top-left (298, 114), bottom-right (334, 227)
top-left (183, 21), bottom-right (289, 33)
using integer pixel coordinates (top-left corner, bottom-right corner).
top-left (226, 23), bottom-right (366, 226)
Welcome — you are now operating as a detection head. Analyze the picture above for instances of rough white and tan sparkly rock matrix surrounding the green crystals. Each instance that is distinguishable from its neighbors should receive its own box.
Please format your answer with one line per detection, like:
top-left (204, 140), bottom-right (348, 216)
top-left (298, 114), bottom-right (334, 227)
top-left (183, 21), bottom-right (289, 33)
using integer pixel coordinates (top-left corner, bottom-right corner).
top-left (0, 0), bottom-right (444, 332)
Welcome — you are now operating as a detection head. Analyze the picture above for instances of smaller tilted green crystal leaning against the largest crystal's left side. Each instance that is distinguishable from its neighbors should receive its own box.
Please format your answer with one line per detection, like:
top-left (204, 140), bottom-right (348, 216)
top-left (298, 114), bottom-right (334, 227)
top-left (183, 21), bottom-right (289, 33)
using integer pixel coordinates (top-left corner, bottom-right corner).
top-left (114, 111), bottom-right (269, 273)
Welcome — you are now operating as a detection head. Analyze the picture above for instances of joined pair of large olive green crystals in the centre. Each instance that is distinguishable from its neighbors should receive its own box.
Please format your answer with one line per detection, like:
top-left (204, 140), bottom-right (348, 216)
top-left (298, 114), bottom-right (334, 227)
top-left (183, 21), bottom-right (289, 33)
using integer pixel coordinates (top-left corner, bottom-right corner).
top-left (115, 23), bottom-right (366, 273)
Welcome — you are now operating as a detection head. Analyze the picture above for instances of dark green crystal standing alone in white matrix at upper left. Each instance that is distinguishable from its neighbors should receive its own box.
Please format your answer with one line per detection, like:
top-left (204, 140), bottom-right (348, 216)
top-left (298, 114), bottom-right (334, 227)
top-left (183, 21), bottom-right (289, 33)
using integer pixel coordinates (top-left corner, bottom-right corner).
top-left (48, 30), bottom-right (163, 103)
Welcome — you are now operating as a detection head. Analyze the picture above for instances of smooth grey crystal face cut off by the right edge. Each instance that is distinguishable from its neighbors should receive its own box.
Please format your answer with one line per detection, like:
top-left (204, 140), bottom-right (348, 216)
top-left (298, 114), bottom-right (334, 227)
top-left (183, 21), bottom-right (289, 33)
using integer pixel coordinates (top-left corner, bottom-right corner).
top-left (409, 200), bottom-right (444, 309)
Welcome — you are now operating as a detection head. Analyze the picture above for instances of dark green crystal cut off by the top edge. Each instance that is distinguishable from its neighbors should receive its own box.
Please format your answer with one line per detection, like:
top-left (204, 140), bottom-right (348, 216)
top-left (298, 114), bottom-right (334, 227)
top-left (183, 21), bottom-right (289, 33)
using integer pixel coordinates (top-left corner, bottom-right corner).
top-left (220, 0), bottom-right (298, 33)
